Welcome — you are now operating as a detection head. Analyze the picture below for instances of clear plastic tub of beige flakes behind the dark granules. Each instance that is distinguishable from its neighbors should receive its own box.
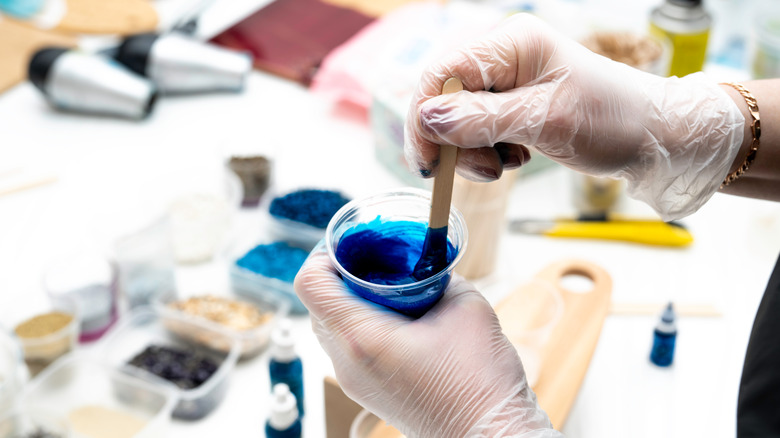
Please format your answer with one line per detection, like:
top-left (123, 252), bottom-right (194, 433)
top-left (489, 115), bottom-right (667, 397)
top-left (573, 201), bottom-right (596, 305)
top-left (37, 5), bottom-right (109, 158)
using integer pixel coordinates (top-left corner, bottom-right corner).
top-left (156, 294), bottom-right (290, 360)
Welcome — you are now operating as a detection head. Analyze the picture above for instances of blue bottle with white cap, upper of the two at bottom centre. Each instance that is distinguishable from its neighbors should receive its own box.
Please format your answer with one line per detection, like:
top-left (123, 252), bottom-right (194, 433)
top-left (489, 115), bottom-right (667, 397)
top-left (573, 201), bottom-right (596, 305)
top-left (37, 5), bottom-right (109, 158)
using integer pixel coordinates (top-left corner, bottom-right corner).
top-left (269, 319), bottom-right (304, 418)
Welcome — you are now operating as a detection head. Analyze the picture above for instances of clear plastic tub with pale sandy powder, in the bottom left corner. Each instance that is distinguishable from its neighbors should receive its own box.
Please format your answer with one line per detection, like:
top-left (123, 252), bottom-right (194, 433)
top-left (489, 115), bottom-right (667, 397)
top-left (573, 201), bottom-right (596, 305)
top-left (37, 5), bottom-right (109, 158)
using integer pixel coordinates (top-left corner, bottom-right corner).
top-left (21, 353), bottom-right (176, 438)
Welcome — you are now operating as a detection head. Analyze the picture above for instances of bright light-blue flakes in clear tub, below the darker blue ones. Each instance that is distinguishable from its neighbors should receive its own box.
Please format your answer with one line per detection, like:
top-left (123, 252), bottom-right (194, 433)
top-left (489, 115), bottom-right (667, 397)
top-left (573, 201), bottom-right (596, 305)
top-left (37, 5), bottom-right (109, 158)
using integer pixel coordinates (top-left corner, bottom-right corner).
top-left (236, 242), bottom-right (309, 283)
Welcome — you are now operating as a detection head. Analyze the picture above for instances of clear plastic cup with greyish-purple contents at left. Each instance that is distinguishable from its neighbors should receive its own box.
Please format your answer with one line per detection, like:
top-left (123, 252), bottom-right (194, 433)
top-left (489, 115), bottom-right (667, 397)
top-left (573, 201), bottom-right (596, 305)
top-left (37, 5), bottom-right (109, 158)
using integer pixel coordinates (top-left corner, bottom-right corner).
top-left (43, 252), bottom-right (119, 342)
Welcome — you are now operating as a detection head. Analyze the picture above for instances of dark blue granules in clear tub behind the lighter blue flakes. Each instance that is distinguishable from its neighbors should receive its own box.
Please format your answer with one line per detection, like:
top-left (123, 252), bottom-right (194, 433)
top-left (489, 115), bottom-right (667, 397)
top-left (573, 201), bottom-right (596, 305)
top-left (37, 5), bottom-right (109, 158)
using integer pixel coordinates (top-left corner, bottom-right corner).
top-left (269, 189), bottom-right (350, 228)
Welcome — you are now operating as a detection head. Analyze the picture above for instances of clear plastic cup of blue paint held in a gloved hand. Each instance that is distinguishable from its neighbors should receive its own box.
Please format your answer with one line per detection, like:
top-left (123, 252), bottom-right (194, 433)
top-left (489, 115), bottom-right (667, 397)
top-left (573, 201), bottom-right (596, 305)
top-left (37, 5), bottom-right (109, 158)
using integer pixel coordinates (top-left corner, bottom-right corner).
top-left (325, 189), bottom-right (468, 317)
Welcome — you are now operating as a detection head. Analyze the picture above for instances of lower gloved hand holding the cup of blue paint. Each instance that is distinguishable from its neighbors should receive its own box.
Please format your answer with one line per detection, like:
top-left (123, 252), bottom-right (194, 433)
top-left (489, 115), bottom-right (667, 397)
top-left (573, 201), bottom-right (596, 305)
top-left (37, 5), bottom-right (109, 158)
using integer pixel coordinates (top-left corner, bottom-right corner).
top-left (295, 249), bottom-right (562, 438)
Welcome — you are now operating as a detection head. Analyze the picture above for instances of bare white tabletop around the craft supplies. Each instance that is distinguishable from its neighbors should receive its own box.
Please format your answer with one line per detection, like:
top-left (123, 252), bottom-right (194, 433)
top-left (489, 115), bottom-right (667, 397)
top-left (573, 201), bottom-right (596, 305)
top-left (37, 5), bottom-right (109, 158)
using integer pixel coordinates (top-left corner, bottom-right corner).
top-left (0, 0), bottom-right (780, 438)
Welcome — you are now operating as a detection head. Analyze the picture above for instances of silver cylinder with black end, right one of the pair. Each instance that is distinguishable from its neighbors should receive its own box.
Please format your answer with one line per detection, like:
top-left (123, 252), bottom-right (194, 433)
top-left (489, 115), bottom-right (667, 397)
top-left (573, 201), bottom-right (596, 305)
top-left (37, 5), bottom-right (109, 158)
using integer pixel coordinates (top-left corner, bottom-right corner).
top-left (116, 32), bottom-right (252, 94)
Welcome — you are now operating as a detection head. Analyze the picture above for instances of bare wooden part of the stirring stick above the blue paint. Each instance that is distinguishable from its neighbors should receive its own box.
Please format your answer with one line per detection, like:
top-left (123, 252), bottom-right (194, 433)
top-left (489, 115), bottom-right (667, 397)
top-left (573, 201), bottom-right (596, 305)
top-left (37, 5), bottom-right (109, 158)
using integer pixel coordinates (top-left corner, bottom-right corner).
top-left (428, 78), bottom-right (463, 229)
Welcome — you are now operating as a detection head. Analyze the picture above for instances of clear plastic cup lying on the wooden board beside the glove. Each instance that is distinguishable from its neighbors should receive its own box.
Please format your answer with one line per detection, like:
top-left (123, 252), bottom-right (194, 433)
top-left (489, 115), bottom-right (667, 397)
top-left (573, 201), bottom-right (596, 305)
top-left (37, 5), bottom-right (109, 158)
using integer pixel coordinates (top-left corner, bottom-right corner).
top-left (497, 279), bottom-right (563, 387)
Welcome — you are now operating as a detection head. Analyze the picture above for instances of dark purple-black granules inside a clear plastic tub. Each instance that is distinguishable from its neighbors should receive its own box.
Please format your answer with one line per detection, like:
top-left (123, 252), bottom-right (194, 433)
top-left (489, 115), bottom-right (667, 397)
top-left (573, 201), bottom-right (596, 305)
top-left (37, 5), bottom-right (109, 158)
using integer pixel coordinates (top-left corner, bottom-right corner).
top-left (128, 345), bottom-right (219, 390)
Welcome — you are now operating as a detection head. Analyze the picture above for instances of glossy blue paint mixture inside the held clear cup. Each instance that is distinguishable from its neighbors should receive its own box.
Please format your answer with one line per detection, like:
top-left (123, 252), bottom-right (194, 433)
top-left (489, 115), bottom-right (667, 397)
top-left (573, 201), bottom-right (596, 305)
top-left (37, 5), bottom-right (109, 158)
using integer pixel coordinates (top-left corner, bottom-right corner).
top-left (335, 218), bottom-right (457, 316)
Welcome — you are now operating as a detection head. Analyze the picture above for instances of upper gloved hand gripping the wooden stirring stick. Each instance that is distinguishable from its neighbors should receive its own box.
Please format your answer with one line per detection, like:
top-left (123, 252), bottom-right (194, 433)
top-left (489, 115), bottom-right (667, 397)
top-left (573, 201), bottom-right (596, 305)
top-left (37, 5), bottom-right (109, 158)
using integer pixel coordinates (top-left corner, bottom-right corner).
top-left (405, 14), bottom-right (745, 220)
